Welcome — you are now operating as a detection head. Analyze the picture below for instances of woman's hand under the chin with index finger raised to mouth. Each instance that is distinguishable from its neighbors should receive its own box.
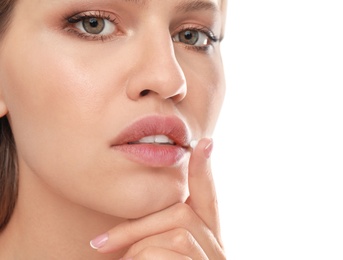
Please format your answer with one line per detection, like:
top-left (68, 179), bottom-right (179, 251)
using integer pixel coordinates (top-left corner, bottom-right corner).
top-left (90, 138), bottom-right (225, 260)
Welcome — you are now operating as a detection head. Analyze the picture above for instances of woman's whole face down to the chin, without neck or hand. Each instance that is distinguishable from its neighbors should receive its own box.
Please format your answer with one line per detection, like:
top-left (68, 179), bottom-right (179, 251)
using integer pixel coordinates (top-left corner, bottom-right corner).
top-left (0, 0), bottom-right (224, 218)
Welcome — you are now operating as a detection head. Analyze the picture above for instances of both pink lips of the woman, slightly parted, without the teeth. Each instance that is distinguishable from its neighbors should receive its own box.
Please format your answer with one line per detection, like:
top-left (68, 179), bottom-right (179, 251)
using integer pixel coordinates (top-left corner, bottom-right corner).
top-left (111, 116), bottom-right (190, 167)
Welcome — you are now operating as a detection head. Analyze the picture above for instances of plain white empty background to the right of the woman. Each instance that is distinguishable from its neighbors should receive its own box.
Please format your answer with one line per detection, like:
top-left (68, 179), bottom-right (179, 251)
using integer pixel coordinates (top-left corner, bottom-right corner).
top-left (212, 0), bottom-right (343, 260)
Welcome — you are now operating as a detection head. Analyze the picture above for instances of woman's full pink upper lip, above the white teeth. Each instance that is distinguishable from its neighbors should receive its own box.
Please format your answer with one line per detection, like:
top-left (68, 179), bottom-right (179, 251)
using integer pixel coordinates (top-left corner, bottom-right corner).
top-left (112, 116), bottom-right (194, 147)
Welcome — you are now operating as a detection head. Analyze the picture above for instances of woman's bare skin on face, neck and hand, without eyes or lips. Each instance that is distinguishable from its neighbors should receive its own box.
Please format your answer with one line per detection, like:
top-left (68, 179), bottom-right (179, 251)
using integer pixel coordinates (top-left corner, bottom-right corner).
top-left (0, 0), bottom-right (225, 259)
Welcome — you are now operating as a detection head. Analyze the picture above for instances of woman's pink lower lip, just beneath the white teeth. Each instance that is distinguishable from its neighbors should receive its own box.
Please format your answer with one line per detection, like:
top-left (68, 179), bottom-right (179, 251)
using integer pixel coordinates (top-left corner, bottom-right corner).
top-left (113, 144), bottom-right (187, 167)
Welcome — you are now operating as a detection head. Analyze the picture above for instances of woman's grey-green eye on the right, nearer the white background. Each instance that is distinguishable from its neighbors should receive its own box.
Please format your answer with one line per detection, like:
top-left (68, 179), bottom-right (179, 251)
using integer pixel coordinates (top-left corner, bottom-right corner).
top-left (173, 29), bottom-right (217, 47)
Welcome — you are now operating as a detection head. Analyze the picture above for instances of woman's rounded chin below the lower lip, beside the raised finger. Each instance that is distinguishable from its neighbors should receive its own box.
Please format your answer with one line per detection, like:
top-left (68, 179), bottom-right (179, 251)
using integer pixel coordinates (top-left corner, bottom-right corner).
top-left (74, 158), bottom-right (189, 219)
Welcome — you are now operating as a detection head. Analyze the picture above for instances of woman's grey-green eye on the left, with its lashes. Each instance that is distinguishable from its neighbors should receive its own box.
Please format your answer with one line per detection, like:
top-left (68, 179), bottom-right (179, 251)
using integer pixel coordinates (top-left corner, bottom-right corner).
top-left (68, 11), bottom-right (117, 40)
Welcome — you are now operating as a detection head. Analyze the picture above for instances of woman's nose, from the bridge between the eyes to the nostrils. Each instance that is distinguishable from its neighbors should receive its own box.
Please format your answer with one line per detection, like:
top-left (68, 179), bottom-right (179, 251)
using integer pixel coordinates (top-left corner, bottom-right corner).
top-left (126, 32), bottom-right (187, 103)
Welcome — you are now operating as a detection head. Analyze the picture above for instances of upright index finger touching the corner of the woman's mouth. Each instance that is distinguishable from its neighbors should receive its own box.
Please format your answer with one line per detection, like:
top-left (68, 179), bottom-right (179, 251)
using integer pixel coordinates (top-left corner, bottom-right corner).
top-left (187, 138), bottom-right (221, 242)
